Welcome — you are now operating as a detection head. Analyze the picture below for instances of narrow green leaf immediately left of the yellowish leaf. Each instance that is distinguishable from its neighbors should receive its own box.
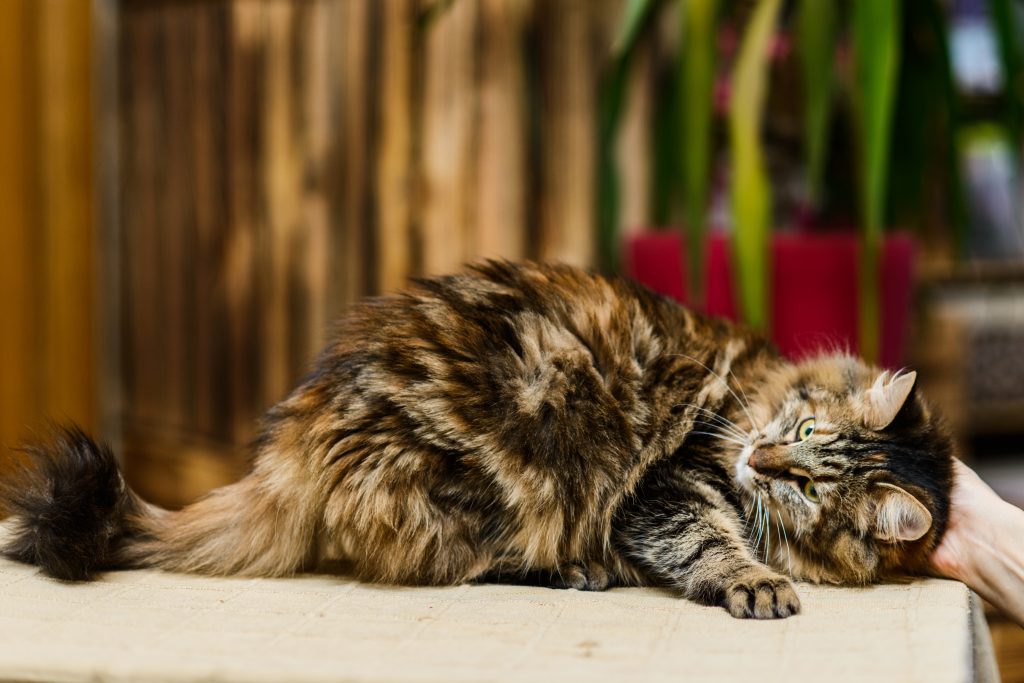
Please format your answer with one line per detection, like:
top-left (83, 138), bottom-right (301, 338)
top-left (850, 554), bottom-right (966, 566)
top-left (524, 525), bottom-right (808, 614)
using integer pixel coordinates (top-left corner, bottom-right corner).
top-left (679, 0), bottom-right (718, 307)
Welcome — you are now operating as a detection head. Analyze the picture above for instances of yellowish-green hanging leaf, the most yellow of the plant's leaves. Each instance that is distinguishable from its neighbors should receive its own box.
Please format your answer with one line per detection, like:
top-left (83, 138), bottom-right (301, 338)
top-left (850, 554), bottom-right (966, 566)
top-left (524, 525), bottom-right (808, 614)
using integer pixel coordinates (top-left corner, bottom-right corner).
top-left (729, 0), bottom-right (781, 330)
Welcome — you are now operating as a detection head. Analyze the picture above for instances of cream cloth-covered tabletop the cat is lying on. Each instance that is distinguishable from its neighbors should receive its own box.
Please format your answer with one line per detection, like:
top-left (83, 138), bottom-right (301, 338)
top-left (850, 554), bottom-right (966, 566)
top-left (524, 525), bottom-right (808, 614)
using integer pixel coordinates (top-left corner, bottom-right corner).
top-left (0, 548), bottom-right (977, 683)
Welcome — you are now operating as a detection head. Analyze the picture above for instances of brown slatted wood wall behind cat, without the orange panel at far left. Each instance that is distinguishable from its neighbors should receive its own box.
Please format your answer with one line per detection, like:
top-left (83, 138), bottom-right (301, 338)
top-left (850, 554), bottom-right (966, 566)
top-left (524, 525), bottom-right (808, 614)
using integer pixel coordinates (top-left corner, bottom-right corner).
top-left (103, 0), bottom-right (649, 503)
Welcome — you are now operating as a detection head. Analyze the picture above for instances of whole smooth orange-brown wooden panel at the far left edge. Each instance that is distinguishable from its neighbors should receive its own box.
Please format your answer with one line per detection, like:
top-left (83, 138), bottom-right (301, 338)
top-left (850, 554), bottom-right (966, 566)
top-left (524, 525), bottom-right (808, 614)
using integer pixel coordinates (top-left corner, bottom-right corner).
top-left (0, 0), bottom-right (96, 483)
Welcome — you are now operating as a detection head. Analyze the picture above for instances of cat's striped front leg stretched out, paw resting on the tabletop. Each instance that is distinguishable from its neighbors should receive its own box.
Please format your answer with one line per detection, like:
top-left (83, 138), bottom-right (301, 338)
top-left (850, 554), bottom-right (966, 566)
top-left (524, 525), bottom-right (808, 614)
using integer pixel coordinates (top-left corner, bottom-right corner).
top-left (616, 486), bottom-right (800, 618)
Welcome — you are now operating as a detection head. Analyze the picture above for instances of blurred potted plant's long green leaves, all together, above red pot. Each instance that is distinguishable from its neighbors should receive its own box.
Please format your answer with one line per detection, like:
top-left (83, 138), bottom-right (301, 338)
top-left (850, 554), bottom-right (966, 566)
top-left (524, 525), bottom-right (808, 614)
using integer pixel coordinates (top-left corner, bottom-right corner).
top-left (600, 0), bottom-right (983, 359)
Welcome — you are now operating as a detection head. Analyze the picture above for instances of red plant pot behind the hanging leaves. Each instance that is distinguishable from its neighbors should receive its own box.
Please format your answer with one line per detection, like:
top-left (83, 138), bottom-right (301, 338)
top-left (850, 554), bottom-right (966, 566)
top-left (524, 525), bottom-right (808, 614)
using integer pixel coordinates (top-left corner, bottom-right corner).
top-left (625, 232), bottom-right (913, 368)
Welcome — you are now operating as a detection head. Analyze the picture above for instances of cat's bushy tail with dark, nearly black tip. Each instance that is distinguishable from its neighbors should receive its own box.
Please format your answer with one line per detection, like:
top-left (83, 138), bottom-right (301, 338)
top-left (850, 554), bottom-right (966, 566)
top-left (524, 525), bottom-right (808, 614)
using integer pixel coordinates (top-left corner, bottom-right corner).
top-left (0, 427), bottom-right (316, 581)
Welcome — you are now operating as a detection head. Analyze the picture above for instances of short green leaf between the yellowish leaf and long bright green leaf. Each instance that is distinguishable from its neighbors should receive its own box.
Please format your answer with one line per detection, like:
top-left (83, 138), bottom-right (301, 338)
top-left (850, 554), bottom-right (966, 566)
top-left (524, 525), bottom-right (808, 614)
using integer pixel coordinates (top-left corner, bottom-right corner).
top-left (797, 0), bottom-right (839, 210)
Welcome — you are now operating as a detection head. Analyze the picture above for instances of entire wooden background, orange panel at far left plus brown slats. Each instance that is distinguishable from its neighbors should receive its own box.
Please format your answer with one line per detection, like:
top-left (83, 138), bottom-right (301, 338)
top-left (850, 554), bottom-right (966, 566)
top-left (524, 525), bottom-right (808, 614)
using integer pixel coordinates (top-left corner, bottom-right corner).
top-left (0, 0), bottom-right (663, 505)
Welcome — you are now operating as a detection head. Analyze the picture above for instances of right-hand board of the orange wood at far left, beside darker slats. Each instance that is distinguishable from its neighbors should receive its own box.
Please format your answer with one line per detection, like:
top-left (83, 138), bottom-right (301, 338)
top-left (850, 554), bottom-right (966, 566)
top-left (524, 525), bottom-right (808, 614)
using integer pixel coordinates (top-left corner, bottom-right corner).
top-left (36, 0), bottom-right (96, 430)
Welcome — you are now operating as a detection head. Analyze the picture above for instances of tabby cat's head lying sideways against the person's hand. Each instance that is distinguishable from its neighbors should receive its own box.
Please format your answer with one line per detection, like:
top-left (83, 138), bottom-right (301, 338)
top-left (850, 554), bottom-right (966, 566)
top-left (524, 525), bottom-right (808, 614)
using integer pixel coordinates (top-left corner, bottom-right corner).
top-left (736, 355), bottom-right (953, 584)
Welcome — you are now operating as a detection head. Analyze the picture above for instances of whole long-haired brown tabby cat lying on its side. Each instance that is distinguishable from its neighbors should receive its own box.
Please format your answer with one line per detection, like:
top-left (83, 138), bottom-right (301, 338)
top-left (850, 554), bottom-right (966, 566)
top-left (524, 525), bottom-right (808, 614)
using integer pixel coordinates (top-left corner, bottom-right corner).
top-left (4, 262), bottom-right (952, 618)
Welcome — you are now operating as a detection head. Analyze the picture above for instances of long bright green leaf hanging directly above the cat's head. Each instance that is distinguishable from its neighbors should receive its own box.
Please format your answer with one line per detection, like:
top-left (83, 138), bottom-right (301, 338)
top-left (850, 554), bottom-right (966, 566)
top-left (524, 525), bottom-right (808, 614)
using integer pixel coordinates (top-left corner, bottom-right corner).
top-left (852, 0), bottom-right (901, 362)
